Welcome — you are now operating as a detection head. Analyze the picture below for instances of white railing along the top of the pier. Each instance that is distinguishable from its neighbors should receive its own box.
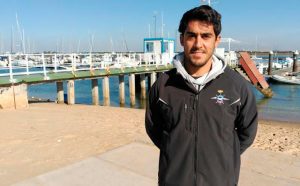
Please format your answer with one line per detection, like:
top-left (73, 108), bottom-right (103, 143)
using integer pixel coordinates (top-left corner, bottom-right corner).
top-left (0, 53), bottom-right (173, 85)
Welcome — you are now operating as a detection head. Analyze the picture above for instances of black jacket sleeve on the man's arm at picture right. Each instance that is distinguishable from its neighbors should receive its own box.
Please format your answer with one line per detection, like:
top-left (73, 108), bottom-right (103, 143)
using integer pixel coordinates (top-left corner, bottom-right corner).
top-left (236, 82), bottom-right (258, 154)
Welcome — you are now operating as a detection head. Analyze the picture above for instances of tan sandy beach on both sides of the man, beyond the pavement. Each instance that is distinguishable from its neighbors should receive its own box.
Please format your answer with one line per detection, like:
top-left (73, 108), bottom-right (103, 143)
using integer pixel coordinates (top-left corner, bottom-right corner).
top-left (0, 103), bottom-right (300, 185)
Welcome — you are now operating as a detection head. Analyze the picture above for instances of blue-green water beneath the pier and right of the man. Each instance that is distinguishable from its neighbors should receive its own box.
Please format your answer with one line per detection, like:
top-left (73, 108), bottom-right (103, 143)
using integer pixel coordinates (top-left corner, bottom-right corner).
top-left (28, 76), bottom-right (300, 122)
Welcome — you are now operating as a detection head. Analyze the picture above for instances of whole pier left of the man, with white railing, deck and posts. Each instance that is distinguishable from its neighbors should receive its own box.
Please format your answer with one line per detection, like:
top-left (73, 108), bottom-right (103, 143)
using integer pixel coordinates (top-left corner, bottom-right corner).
top-left (0, 53), bottom-right (173, 108)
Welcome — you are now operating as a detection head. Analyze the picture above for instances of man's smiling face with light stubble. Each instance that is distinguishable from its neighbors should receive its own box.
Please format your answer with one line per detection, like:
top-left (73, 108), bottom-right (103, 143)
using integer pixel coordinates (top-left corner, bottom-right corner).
top-left (180, 20), bottom-right (221, 69)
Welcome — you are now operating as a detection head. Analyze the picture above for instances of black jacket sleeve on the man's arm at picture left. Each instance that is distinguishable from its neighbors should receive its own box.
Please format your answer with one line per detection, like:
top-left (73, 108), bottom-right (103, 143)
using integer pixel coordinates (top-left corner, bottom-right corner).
top-left (145, 81), bottom-right (162, 148)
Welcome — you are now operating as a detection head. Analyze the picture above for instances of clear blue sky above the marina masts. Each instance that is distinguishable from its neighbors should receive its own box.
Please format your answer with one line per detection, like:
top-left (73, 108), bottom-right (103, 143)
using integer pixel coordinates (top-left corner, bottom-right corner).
top-left (0, 0), bottom-right (300, 53)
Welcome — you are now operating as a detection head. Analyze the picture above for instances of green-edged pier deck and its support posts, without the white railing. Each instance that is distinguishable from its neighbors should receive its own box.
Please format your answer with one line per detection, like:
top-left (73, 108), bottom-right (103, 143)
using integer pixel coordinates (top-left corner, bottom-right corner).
top-left (0, 60), bottom-right (173, 108)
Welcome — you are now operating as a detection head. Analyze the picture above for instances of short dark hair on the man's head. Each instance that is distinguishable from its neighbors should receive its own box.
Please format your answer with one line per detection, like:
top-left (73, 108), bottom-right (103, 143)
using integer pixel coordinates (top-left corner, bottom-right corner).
top-left (178, 5), bottom-right (222, 36)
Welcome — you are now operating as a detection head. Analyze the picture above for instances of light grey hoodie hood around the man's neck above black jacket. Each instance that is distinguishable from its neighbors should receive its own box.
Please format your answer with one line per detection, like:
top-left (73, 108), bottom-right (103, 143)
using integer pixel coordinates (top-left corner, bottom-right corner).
top-left (173, 52), bottom-right (226, 91)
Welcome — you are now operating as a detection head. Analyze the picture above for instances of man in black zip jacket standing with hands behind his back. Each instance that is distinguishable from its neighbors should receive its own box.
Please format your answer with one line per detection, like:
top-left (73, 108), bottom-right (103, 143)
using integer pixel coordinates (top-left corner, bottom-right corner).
top-left (146, 5), bottom-right (257, 186)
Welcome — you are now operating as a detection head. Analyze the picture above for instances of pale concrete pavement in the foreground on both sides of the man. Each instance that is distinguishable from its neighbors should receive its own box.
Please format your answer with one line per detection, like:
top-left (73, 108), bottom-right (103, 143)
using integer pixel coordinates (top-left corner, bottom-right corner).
top-left (14, 142), bottom-right (300, 186)
